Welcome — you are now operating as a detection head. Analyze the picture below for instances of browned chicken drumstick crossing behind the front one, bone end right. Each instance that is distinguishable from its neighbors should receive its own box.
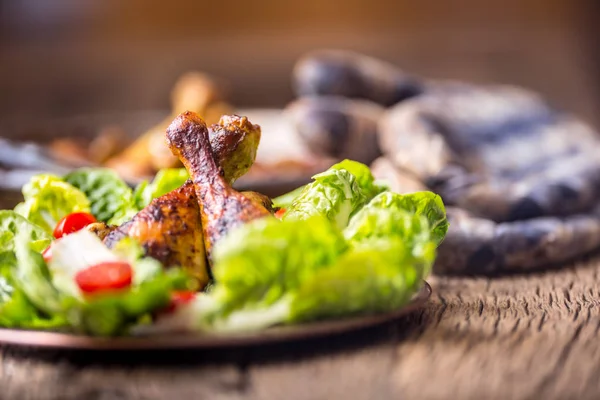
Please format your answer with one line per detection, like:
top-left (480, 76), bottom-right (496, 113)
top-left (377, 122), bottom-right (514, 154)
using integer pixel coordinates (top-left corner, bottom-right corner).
top-left (102, 114), bottom-right (272, 287)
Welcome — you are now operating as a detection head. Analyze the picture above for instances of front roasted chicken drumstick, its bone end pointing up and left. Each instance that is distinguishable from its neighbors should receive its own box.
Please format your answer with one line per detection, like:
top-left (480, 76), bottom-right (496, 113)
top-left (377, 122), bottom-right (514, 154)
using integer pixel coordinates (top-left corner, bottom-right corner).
top-left (167, 111), bottom-right (270, 261)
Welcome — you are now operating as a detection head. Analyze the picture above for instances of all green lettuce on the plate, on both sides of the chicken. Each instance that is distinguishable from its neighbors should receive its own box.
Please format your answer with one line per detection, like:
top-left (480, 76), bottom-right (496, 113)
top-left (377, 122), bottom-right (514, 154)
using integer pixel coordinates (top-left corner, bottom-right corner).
top-left (0, 160), bottom-right (448, 336)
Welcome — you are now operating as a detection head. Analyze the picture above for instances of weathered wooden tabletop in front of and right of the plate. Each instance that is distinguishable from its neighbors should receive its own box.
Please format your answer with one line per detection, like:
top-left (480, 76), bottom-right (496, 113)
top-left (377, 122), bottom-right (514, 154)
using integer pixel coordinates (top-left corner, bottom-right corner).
top-left (0, 258), bottom-right (600, 400)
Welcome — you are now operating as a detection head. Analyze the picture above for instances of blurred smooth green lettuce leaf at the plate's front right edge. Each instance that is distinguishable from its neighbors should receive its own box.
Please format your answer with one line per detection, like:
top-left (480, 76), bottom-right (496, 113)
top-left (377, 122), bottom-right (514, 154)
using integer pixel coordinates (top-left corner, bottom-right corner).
top-left (284, 239), bottom-right (428, 323)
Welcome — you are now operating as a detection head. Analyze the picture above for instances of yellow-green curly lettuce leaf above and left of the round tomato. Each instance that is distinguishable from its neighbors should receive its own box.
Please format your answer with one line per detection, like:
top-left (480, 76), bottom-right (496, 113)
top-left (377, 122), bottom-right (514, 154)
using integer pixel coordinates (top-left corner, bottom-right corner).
top-left (15, 174), bottom-right (90, 233)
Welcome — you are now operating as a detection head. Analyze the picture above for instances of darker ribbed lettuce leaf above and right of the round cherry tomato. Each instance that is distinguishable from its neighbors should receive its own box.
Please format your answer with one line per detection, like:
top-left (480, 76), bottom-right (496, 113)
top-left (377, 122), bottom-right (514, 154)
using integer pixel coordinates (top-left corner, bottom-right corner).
top-left (64, 168), bottom-right (138, 225)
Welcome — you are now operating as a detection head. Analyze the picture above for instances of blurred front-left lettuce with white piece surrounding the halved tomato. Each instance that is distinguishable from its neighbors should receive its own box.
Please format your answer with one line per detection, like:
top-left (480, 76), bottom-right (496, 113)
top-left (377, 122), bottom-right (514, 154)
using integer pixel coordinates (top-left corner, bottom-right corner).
top-left (0, 230), bottom-right (190, 336)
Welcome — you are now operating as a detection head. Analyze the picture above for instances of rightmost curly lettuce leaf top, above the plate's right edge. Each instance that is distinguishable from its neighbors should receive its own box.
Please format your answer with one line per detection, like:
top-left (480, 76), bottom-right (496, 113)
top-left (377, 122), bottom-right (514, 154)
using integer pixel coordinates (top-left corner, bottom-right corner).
top-left (344, 192), bottom-right (449, 245)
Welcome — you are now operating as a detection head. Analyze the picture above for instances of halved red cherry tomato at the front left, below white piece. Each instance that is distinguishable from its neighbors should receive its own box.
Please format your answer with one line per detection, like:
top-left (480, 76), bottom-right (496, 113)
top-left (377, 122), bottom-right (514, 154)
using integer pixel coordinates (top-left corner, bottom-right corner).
top-left (75, 261), bottom-right (133, 294)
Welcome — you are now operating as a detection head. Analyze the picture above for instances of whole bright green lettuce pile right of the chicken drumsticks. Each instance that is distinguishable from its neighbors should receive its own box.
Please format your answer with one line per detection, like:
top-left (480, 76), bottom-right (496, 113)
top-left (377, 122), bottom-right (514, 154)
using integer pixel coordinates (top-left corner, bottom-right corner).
top-left (198, 160), bottom-right (448, 332)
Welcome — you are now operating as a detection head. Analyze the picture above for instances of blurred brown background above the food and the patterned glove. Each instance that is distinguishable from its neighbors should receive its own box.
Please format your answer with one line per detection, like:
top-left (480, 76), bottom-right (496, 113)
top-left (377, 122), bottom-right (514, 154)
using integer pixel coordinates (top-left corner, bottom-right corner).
top-left (0, 0), bottom-right (600, 126)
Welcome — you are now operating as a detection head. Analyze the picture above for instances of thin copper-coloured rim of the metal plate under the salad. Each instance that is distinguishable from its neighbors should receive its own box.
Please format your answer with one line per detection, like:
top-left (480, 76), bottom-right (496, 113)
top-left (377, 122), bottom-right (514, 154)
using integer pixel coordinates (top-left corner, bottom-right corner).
top-left (0, 282), bottom-right (431, 351)
